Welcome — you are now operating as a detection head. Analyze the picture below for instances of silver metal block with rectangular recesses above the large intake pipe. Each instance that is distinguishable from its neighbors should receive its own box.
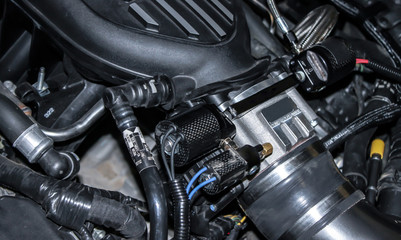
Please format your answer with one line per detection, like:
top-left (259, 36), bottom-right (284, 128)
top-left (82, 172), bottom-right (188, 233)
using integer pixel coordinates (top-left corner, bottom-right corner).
top-left (233, 88), bottom-right (317, 169)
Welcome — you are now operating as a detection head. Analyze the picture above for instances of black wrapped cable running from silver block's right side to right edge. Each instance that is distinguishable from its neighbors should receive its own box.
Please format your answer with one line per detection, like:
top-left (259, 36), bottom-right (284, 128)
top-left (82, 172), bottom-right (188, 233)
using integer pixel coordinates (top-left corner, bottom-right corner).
top-left (322, 103), bottom-right (401, 150)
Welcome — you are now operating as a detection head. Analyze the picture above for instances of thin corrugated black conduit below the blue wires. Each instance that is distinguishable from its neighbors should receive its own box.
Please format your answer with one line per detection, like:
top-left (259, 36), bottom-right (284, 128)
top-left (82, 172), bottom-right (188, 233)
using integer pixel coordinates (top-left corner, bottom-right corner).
top-left (169, 178), bottom-right (190, 240)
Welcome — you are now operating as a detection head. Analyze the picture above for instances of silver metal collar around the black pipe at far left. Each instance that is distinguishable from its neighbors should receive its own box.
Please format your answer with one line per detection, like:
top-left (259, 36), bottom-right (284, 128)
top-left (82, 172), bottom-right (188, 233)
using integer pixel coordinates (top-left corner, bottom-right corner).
top-left (13, 124), bottom-right (53, 163)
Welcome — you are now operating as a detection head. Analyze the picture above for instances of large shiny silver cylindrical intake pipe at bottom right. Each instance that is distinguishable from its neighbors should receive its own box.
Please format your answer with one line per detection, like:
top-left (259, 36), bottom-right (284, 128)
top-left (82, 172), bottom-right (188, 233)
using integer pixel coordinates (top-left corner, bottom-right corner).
top-left (240, 139), bottom-right (401, 239)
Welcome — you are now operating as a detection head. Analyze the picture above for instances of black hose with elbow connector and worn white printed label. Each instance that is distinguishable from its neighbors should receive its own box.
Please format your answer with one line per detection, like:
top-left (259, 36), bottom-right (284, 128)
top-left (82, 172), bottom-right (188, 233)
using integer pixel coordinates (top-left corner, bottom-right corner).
top-left (103, 86), bottom-right (171, 240)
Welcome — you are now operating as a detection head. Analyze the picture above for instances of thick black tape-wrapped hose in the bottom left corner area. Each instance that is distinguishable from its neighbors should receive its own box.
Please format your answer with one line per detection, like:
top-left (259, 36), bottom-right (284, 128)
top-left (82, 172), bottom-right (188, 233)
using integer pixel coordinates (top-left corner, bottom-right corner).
top-left (0, 156), bottom-right (146, 239)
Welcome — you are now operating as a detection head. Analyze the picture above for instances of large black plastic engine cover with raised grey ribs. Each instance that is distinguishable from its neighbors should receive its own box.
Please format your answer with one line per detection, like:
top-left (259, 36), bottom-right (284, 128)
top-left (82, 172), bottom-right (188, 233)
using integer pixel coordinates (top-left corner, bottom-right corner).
top-left (13, 0), bottom-right (266, 96)
